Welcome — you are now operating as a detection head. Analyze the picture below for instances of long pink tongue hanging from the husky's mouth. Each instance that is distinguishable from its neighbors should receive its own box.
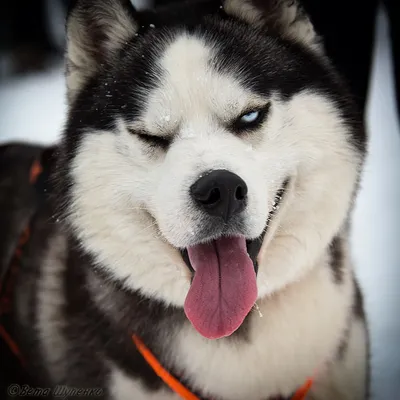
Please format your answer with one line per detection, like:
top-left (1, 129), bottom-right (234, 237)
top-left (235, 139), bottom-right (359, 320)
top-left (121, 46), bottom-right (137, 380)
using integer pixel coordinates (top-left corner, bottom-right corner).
top-left (185, 237), bottom-right (257, 339)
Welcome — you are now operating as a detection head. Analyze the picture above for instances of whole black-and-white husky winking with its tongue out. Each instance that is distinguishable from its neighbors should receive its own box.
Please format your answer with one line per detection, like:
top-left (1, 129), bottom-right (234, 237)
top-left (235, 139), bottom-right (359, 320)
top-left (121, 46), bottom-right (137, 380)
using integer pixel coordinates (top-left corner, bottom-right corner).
top-left (0, 0), bottom-right (369, 400)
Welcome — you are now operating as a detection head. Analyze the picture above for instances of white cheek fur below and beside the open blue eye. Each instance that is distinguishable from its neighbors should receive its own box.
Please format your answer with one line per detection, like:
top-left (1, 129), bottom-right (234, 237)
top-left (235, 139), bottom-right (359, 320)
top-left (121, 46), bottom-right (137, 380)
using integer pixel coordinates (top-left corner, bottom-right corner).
top-left (258, 92), bottom-right (362, 297)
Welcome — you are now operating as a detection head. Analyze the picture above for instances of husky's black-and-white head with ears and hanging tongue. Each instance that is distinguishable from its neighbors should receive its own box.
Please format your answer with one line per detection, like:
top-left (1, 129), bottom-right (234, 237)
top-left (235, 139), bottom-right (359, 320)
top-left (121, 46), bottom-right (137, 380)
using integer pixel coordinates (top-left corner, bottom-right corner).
top-left (61, 0), bottom-right (363, 338)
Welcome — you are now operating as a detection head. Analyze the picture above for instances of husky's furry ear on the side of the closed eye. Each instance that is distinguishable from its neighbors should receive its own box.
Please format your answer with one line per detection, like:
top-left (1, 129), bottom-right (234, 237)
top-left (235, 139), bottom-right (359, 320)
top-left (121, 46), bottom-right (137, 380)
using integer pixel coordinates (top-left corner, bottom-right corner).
top-left (66, 0), bottom-right (139, 101)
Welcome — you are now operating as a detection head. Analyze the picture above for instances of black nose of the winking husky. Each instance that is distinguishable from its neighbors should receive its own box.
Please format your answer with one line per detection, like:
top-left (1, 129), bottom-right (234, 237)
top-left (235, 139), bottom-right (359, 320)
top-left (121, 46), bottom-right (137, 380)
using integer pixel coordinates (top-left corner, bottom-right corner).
top-left (190, 170), bottom-right (247, 222)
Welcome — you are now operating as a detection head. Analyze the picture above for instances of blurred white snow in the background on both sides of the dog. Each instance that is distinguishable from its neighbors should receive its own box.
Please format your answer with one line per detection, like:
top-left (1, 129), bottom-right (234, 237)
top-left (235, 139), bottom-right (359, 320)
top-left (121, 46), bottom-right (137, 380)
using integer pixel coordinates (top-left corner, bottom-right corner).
top-left (0, 6), bottom-right (400, 400)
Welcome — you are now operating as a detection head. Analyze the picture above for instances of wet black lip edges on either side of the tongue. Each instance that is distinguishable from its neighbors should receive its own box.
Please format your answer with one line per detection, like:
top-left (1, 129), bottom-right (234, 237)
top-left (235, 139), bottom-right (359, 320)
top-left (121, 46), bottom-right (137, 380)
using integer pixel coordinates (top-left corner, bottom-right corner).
top-left (180, 178), bottom-right (290, 274)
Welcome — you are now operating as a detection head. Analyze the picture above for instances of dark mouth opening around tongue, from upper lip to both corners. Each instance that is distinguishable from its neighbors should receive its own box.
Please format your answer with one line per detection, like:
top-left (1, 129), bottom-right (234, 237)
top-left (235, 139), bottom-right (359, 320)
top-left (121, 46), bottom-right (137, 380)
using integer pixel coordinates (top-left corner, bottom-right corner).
top-left (179, 179), bottom-right (290, 274)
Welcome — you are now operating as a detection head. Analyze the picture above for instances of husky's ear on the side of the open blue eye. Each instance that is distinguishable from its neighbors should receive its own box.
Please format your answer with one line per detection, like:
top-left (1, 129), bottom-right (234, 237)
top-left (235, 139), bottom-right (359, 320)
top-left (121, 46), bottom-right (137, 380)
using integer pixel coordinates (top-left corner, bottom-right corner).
top-left (223, 0), bottom-right (322, 51)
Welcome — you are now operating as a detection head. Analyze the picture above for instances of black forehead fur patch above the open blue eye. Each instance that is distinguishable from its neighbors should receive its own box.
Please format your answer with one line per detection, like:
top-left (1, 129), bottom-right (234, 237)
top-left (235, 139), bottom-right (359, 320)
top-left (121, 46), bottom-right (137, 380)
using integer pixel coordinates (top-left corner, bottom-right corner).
top-left (197, 17), bottom-right (366, 155)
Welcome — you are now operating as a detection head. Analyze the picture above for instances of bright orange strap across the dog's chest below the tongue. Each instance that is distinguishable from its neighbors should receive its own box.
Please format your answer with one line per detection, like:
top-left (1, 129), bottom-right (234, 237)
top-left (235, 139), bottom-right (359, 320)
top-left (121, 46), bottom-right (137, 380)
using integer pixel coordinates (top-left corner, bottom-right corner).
top-left (132, 335), bottom-right (313, 400)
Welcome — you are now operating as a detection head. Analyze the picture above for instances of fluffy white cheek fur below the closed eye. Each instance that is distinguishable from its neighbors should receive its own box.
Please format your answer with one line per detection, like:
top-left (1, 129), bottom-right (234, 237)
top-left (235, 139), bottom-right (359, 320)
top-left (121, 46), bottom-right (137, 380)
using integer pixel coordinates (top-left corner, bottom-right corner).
top-left (68, 131), bottom-right (190, 306)
